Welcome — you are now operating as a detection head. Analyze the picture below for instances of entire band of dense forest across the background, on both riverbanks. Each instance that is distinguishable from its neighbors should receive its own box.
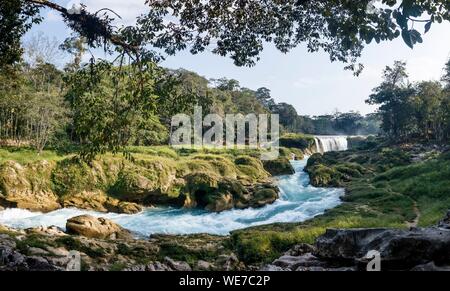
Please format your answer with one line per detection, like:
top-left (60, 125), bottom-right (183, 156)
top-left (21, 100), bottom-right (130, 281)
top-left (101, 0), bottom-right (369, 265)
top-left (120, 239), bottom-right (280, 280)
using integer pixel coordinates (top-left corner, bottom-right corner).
top-left (0, 35), bottom-right (450, 159)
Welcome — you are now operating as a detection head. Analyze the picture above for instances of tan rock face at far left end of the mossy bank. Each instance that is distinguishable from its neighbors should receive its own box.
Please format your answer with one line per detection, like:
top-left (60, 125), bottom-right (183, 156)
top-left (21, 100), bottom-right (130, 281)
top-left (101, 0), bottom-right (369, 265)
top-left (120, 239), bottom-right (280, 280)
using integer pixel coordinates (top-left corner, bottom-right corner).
top-left (0, 161), bottom-right (61, 212)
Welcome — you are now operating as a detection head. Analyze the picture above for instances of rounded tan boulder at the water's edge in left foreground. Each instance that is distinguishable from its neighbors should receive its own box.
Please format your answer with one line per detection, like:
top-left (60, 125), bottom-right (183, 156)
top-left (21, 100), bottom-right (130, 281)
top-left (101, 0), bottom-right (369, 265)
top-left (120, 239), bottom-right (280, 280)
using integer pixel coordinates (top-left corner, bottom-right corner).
top-left (66, 215), bottom-right (132, 239)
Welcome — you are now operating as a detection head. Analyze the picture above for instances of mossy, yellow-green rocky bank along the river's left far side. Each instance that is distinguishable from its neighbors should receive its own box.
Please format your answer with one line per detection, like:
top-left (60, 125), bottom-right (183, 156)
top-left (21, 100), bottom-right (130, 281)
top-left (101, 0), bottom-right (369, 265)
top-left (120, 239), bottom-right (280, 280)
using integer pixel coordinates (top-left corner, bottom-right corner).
top-left (0, 148), bottom-right (294, 214)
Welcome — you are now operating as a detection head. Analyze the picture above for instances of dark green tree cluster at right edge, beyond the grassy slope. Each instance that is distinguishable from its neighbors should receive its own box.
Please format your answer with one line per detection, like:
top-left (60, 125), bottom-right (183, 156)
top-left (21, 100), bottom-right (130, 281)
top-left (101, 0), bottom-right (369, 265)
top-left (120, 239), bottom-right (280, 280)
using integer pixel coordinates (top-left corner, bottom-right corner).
top-left (367, 61), bottom-right (450, 143)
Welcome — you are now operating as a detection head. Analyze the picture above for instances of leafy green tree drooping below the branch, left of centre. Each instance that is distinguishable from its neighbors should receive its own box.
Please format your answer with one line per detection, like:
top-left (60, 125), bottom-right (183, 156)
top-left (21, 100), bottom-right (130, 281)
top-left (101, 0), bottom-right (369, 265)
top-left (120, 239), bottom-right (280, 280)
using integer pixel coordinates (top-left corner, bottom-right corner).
top-left (66, 61), bottom-right (160, 160)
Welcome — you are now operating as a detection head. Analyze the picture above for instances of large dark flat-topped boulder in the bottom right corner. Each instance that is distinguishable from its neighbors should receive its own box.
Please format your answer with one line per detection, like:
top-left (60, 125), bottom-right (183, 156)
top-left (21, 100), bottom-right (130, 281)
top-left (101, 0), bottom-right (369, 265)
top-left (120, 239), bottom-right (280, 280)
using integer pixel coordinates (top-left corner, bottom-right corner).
top-left (315, 227), bottom-right (450, 270)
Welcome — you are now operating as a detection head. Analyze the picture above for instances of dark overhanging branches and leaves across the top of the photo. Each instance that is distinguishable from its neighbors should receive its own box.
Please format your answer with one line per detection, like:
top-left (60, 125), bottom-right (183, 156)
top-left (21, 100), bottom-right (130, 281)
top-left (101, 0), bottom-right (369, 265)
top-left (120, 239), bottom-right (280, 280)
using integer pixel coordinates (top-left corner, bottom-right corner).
top-left (0, 0), bottom-right (450, 70)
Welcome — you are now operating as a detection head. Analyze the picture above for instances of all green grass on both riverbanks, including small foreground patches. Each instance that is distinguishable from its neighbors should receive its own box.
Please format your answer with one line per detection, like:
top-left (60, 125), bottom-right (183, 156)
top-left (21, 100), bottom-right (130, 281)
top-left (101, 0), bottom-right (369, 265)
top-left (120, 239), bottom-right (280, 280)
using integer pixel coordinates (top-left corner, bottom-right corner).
top-left (0, 147), bottom-right (450, 269)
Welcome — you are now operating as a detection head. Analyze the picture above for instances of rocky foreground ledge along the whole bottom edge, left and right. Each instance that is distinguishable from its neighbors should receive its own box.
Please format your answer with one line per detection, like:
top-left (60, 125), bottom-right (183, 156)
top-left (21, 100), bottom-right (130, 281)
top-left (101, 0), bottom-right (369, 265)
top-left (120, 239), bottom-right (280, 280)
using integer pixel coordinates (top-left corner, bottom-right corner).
top-left (0, 212), bottom-right (450, 271)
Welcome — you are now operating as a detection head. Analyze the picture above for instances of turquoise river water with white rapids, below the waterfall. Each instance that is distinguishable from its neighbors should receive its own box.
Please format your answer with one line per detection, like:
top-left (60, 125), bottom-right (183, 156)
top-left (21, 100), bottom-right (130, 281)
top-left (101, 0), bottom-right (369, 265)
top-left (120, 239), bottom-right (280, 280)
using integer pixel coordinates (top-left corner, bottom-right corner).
top-left (0, 160), bottom-right (344, 236)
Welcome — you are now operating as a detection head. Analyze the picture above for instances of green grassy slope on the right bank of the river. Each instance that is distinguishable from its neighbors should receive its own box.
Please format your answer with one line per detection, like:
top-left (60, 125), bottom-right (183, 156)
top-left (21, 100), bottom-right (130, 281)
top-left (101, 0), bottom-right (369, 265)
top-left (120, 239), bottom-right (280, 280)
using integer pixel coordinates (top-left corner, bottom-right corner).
top-left (231, 149), bottom-right (450, 264)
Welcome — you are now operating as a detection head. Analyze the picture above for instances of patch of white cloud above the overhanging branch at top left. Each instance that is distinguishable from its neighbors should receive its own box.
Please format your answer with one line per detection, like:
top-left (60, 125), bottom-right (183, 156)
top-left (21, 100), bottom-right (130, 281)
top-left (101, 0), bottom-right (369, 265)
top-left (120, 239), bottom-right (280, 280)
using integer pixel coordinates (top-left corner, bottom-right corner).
top-left (67, 0), bottom-right (149, 25)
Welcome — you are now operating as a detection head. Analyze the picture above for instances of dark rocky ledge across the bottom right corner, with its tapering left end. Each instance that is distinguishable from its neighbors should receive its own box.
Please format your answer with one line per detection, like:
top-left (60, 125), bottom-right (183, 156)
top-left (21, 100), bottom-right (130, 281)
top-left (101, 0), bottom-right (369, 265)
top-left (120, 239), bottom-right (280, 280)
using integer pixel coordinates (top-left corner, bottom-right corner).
top-left (261, 212), bottom-right (450, 271)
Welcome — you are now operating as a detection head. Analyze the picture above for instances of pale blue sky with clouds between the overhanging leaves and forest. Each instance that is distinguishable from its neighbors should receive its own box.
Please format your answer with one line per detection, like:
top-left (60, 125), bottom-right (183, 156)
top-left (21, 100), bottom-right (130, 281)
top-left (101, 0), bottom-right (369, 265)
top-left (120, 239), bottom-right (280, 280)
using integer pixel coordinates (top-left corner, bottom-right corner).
top-left (25, 0), bottom-right (450, 116)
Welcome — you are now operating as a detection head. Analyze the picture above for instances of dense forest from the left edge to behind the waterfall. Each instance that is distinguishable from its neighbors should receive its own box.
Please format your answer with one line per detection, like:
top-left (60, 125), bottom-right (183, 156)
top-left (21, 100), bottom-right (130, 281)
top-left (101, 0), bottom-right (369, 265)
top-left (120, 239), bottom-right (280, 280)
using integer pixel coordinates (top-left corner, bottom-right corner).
top-left (0, 34), bottom-right (379, 160)
